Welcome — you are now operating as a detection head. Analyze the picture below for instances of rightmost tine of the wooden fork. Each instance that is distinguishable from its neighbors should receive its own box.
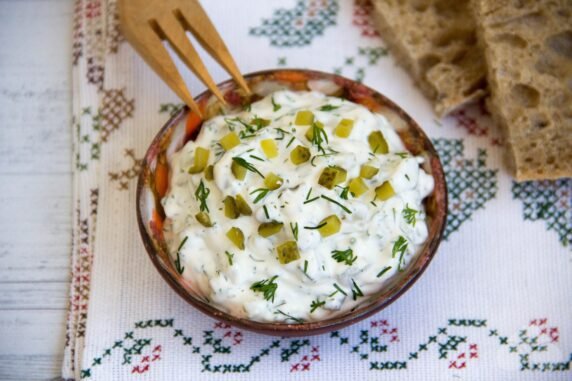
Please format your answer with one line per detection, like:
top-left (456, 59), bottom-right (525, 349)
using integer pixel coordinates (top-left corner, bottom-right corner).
top-left (175, 0), bottom-right (250, 94)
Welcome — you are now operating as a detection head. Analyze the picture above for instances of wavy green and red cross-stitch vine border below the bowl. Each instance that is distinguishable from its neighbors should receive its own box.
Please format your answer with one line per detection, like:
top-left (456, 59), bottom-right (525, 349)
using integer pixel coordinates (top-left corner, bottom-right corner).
top-left (81, 318), bottom-right (572, 379)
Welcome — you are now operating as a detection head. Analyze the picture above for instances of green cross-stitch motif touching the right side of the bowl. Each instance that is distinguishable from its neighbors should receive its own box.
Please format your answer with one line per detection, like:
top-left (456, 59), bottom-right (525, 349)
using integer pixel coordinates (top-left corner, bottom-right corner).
top-left (433, 139), bottom-right (497, 239)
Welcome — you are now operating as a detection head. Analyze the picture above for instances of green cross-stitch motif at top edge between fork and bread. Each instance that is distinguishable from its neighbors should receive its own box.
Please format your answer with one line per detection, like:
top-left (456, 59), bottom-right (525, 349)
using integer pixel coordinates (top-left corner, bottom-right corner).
top-left (250, 0), bottom-right (339, 47)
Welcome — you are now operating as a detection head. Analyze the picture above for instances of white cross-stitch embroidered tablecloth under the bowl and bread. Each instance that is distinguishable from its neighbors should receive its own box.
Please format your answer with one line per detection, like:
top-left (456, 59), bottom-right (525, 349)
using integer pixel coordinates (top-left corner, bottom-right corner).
top-left (63, 0), bottom-right (572, 380)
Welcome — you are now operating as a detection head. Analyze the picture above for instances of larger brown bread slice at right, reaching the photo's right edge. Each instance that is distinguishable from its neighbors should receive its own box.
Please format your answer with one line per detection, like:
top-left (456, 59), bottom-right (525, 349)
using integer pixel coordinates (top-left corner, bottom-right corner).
top-left (472, 0), bottom-right (572, 181)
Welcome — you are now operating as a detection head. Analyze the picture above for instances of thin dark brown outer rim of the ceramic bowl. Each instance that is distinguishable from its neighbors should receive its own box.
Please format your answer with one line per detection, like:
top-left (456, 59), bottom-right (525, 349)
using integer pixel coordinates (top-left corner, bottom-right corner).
top-left (136, 68), bottom-right (448, 337)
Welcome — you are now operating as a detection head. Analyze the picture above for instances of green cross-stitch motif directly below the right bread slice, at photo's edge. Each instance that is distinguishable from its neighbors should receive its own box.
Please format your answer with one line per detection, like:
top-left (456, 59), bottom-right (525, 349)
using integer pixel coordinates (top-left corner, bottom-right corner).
top-left (512, 179), bottom-right (572, 249)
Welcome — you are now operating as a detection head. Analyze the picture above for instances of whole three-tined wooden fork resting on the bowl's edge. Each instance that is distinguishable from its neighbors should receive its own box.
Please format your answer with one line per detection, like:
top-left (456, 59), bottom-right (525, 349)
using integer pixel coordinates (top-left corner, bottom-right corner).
top-left (118, 0), bottom-right (250, 116)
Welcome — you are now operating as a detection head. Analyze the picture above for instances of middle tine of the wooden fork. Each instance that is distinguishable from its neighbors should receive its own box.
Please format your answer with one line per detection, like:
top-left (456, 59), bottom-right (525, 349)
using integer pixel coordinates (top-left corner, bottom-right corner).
top-left (157, 12), bottom-right (226, 104)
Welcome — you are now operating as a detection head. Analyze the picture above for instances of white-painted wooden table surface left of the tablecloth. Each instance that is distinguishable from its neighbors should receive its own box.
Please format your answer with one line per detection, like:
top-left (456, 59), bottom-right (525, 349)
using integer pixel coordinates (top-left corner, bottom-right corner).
top-left (0, 0), bottom-right (73, 380)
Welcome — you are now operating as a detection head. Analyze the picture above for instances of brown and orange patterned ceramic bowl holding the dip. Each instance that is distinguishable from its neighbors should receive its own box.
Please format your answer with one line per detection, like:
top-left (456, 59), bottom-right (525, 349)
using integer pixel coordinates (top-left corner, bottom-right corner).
top-left (137, 69), bottom-right (447, 336)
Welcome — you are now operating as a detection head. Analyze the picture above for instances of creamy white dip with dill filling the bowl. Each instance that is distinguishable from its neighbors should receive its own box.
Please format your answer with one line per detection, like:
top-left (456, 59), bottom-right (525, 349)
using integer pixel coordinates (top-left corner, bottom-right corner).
top-left (162, 91), bottom-right (434, 323)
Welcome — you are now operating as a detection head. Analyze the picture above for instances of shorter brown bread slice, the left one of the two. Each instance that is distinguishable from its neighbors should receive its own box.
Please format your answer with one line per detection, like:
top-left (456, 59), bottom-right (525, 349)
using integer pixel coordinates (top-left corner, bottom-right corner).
top-left (373, 0), bottom-right (486, 116)
